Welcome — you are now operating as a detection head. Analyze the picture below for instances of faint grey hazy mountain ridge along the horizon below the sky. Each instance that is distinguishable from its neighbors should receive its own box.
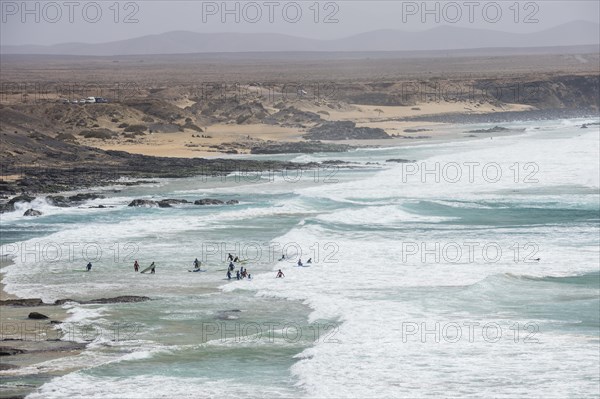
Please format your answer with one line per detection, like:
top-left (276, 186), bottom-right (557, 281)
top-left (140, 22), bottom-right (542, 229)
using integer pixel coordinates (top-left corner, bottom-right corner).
top-left (0, 21), bottom-right (600, 56)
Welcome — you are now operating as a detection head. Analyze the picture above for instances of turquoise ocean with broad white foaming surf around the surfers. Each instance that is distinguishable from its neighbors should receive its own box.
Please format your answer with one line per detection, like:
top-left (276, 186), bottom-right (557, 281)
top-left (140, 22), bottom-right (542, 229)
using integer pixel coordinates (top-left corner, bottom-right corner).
top-left (0, 119), bottom-right (600, 398)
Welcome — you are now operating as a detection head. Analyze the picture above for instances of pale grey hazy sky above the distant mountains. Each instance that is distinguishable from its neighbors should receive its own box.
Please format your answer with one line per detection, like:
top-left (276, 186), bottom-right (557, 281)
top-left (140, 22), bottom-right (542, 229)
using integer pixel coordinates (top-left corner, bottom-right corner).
top-left (0, 0), bottom-right (600, 45)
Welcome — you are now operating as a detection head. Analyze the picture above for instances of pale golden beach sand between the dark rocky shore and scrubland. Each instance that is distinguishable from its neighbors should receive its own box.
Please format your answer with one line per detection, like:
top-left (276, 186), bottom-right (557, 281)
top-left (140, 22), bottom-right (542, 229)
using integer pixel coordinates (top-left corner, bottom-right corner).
top-left (85, 101), bottom-right (534, 158)
